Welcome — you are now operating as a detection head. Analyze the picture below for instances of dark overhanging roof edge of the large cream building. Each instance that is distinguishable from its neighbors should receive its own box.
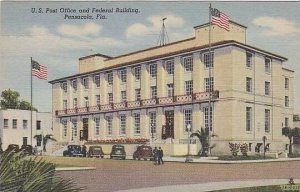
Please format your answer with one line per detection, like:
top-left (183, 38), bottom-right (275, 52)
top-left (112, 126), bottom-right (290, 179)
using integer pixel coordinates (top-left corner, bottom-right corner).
top-left (49, 38), bottom-right (288, 84)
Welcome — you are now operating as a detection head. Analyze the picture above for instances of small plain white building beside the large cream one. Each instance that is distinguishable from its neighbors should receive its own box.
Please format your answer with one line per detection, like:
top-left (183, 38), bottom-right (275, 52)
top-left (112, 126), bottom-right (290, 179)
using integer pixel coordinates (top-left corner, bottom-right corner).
top-left (0, 109), bottom-right (52, 150)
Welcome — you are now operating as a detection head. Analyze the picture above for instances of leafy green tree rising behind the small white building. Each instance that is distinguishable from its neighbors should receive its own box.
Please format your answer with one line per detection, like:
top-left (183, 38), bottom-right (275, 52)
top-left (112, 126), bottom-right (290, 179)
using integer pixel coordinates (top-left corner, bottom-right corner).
top-left (0, 89), bottom-right (37, 111)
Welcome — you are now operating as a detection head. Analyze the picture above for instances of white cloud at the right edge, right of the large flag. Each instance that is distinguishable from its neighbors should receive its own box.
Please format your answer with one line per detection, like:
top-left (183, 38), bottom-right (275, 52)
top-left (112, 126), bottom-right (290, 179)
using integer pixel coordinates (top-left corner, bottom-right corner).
top-left (252, 16), bottom-right (300, 36)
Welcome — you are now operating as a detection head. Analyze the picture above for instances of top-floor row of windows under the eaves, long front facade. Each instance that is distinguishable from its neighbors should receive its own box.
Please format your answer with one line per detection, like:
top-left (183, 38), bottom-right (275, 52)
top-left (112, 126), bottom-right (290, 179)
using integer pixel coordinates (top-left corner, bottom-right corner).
top-left (61, 53), bottom-right (213, 92)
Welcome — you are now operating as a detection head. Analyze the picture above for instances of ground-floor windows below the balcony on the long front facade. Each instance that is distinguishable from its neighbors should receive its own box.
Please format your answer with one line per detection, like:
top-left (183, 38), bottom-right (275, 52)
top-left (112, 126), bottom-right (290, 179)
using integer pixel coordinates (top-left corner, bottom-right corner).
top-left (62, 107), bottom-right (212, 139)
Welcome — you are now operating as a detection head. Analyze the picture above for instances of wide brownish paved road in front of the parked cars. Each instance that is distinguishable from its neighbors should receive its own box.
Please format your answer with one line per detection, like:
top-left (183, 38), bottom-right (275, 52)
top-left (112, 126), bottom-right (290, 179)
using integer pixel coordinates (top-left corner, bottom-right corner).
top-left (55, 158), bottom-right (300, 192)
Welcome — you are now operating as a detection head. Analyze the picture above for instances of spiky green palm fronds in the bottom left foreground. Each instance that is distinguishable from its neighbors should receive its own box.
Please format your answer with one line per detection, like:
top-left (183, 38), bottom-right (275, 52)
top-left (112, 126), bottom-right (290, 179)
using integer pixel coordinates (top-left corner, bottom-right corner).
top-left (0, 152), bottom-right (82, 192)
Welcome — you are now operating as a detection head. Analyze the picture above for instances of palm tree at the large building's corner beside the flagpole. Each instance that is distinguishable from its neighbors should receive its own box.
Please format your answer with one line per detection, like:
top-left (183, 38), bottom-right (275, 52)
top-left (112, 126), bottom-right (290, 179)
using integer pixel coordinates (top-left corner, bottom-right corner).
top-left (190, 127), bottom-right (216, 157)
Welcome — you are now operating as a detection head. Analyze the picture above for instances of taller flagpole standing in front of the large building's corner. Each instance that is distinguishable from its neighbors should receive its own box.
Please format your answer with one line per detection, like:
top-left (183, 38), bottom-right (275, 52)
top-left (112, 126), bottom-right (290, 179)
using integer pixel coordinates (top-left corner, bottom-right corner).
top-left (208, 3), bottom-right (212, 154)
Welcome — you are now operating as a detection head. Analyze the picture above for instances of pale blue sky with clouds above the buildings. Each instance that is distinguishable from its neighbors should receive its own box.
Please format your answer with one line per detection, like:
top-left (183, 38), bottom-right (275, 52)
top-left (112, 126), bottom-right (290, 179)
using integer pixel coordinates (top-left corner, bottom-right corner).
top-left (0, 1), bottom-right (300, 113)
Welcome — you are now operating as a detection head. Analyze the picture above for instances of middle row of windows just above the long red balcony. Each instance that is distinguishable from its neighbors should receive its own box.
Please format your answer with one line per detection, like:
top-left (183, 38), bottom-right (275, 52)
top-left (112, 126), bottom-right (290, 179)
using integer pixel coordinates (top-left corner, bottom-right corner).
top-left (63, 77), bottom-right (214, 109)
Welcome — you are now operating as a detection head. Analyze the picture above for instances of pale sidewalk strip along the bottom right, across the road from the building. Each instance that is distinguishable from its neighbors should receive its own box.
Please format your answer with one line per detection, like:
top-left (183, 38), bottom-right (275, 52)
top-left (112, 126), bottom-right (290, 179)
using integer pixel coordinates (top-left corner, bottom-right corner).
top-left (119, 179), bottom-right (300, 192)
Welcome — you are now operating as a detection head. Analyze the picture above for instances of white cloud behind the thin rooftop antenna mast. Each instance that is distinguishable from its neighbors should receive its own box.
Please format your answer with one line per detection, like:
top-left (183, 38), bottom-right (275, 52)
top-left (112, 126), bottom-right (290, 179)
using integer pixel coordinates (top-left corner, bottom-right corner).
top-left (126, 13), bottom-right (185, 38)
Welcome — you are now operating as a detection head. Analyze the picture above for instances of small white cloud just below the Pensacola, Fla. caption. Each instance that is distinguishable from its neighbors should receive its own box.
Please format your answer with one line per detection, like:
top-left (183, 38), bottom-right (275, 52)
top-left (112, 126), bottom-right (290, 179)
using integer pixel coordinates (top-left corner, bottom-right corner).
top-left (57, 23), bottom-right (102, 37)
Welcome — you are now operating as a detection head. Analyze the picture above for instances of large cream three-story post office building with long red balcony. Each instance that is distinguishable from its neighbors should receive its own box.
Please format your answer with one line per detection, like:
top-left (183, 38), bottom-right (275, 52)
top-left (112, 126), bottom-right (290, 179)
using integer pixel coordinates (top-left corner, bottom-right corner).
top-left (50, 21), bottom-right (294, 154)
